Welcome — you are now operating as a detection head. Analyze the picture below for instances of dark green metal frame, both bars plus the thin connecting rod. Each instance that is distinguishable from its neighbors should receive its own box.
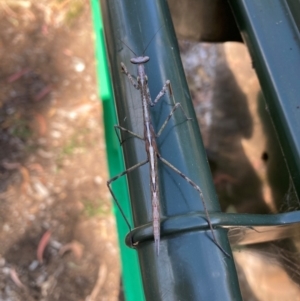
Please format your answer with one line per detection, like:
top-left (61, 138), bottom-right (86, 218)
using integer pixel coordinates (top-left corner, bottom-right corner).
top-left (93, 0), bottom-right (300, 300)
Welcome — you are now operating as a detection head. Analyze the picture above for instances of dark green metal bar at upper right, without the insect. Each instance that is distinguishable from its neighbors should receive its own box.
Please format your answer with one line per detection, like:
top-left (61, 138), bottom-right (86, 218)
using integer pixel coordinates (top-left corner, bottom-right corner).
top-left (229, 0), bottom-right (300, 199)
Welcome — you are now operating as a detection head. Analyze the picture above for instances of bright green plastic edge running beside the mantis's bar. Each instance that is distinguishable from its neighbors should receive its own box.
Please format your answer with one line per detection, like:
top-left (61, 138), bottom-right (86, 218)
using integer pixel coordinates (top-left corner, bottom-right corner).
top-left (90, 0), bottom-right (145, 301)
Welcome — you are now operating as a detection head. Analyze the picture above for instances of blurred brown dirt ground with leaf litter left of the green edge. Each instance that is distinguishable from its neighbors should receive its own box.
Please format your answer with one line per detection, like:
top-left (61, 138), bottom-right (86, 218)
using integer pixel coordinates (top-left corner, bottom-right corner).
top-left (0, 0), bottom-right (120, 301)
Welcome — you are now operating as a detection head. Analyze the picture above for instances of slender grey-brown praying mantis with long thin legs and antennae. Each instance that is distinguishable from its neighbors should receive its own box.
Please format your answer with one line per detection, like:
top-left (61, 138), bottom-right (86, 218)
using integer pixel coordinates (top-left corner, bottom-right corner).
top-left (107, 43), bottom-right (230, 257)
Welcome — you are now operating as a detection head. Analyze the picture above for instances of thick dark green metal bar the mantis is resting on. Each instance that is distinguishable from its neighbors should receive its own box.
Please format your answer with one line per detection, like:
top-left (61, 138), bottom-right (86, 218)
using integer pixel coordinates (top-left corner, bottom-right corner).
top-left (102, 0), bottom-right (241, 301)
